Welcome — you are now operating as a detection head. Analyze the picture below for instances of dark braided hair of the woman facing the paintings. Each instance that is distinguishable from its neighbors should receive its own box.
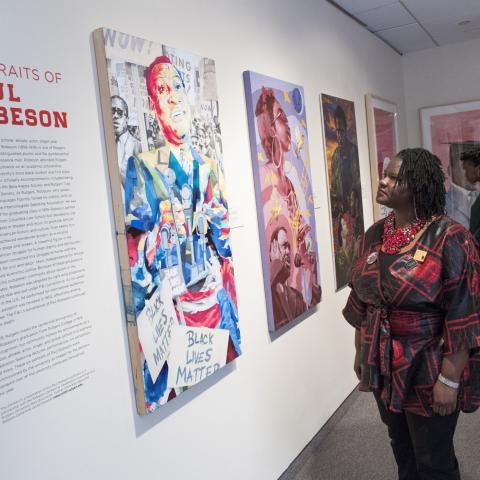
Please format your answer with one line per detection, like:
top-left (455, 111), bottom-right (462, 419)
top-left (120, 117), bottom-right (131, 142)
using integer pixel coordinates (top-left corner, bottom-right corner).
top-left (397, 148), bottom-right (445, 220)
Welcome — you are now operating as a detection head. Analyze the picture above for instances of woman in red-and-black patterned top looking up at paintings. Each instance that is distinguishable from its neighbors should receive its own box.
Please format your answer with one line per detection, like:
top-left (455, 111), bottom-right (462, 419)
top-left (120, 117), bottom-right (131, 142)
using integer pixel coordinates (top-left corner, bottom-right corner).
top-left (343, 148), bottom-right (480, 480)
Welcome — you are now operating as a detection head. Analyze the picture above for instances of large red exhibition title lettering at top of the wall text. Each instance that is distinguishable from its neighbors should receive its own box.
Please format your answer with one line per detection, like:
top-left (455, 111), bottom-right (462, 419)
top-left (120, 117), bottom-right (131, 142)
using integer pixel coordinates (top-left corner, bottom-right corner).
top-left (0, 63), bottom-right (68, 128)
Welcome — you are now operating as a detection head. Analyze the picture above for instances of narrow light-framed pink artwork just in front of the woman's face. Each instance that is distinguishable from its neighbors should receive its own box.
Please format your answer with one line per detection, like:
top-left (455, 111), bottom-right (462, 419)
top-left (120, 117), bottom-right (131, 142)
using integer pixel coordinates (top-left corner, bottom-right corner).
top-left (365, 93), bottom-right (398, 221)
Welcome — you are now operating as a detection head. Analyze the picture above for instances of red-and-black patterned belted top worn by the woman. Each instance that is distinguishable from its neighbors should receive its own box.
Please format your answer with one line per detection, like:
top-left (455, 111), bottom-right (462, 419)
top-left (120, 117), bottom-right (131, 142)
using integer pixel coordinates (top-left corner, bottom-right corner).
top-left (343, 217), bottom-right (480, 416)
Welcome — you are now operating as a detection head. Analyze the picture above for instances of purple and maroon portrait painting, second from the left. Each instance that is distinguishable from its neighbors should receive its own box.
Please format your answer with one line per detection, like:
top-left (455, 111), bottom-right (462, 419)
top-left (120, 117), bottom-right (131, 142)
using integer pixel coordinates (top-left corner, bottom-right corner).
top-left (244, 72), bottom-right (321, 331)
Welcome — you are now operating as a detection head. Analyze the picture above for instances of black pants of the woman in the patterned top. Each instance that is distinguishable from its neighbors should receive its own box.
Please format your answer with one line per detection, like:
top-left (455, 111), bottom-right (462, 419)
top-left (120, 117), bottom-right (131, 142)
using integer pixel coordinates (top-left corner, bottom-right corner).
top-left (374, 393), bottom-right (460, 480)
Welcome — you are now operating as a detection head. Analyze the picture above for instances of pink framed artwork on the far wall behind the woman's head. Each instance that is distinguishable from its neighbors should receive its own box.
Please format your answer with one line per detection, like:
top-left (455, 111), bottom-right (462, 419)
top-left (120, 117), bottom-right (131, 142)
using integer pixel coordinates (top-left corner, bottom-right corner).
top-left (420, 100), bottom-right (480, 229)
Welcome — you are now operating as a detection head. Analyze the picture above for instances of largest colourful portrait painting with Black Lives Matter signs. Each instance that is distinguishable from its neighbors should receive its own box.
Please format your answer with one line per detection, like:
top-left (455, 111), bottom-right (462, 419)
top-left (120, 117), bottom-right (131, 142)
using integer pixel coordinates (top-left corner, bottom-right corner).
top-left (94, 29), bottom-right (241, 414)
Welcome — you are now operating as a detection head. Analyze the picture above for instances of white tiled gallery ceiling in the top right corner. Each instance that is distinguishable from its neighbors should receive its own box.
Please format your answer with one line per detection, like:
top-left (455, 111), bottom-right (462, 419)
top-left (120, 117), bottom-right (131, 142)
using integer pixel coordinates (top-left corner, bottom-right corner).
top-left (327, 0), bottom-right (480, 54)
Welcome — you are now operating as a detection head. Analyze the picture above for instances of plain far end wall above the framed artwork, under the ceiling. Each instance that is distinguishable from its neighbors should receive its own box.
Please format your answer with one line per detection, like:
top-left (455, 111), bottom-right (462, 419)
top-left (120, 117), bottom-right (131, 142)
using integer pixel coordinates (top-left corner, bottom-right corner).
top-left (402, 39), bottom-right (480, 147)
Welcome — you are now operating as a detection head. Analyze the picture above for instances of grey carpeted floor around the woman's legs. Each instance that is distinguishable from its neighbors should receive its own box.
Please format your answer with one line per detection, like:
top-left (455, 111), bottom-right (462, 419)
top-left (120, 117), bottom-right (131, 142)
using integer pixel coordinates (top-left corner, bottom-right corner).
top-left (279, 390), bottom-right (480, 480)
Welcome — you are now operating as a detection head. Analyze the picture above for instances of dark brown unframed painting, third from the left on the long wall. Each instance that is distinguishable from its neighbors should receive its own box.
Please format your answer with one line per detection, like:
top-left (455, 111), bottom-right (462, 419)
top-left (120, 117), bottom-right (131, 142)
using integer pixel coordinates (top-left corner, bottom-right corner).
top-left (321, 94), bottom-right (364, 290)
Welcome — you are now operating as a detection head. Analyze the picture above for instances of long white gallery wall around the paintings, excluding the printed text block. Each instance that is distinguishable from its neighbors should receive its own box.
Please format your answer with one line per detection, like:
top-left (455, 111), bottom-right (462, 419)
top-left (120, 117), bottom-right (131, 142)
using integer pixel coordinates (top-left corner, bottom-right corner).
top-left (0, 0), bottom-right (405, 480)
